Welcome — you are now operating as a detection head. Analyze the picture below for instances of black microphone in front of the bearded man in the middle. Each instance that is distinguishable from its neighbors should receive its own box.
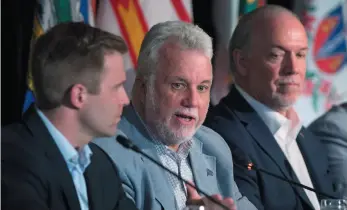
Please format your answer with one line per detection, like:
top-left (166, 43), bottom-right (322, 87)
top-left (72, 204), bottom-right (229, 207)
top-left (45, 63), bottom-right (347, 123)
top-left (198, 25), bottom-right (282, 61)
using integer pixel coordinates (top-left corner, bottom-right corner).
top-left (116, 136), bottom-right (229, 209)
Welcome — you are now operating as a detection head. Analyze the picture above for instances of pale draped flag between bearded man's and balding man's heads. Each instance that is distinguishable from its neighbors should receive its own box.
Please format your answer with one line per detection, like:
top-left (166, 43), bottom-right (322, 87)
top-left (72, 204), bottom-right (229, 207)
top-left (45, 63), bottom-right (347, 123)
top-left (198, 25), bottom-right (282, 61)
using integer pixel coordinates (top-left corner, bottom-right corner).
top-left (211, 0), bottom-right (266, 105)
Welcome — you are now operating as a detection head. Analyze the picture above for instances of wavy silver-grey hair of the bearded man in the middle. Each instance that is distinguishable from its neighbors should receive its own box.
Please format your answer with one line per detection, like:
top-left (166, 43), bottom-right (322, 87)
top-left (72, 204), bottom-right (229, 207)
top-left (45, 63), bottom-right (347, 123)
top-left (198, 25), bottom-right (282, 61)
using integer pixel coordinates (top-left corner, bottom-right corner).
top-left (136, 21), bottom-right (213, 79)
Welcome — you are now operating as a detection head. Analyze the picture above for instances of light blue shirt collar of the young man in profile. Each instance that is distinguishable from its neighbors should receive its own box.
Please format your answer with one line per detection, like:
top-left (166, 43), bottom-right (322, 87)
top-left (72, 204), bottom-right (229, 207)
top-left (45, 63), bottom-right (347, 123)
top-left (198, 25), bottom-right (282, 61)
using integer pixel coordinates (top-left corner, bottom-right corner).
top-left (36, 109), bottom-right (93, 170)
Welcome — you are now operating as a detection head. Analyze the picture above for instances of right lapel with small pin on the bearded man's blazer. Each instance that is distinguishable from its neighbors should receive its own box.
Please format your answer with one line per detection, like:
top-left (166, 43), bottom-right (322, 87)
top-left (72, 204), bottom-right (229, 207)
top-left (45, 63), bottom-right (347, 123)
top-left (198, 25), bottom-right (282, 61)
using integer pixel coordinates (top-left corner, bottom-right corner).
top-left (189, 138), bottom-right (220, 196)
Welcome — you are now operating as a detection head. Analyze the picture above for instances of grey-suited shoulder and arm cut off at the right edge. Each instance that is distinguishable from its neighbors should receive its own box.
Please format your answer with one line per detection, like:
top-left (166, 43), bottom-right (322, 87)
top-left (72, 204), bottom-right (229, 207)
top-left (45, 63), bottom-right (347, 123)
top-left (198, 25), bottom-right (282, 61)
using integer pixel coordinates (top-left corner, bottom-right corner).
top-left (308, 102), bottom-right (347, 199)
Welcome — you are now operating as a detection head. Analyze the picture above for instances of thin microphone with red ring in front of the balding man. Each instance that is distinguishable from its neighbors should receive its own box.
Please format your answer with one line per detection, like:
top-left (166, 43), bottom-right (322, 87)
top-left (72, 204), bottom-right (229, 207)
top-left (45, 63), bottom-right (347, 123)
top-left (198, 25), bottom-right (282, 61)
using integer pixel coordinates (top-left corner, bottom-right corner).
top-left (233, 150), bottom-right (338, 199)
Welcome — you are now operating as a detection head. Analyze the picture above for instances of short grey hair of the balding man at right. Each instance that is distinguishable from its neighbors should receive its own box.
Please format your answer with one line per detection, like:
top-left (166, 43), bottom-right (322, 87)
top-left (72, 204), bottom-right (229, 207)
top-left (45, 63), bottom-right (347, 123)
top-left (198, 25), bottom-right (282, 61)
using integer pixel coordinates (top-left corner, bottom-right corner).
top-left (229, 4), bottom-right (300, 79)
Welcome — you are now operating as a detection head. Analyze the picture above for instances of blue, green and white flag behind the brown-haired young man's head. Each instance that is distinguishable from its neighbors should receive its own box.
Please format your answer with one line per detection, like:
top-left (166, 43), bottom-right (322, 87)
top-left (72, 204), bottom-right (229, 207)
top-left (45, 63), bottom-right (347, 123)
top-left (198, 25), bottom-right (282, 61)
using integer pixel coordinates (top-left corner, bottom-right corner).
top-left (23, 0), bottom-right (96, 112)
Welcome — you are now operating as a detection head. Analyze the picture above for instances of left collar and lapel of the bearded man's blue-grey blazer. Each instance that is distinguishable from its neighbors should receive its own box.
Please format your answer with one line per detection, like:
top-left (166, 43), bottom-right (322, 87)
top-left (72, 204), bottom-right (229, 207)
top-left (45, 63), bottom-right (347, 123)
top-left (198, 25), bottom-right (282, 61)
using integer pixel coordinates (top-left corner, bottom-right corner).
top-left (120, 105), bottom-right (176, 209)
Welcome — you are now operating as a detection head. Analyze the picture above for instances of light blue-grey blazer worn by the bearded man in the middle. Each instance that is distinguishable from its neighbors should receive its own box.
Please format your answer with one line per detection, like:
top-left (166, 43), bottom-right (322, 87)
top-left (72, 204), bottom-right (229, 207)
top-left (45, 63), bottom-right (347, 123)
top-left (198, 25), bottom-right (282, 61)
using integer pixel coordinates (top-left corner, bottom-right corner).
top-left (94, 105), bottom-right (256, 210)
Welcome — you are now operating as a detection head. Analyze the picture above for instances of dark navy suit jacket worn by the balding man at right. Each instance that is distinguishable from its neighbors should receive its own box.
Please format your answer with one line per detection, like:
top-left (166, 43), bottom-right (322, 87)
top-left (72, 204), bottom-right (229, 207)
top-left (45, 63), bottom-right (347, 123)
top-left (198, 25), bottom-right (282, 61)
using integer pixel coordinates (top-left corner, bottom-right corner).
top-left (205, 87), bottom-right (333, 210)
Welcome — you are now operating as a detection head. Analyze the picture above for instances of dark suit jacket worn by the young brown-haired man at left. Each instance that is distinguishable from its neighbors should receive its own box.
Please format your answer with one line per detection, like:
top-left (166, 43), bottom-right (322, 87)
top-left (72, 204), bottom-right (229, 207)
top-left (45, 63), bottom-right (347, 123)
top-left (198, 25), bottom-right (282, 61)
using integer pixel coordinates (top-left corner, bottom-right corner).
top-left (1, 107), bottom-right (136, 210)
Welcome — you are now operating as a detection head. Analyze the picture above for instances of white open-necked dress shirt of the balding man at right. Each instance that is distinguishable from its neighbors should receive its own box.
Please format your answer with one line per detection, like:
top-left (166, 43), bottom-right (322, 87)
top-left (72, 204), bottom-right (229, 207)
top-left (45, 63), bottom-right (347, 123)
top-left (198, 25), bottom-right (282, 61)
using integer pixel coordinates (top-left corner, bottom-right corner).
top-left (235, 85), bottom-right (320, 210)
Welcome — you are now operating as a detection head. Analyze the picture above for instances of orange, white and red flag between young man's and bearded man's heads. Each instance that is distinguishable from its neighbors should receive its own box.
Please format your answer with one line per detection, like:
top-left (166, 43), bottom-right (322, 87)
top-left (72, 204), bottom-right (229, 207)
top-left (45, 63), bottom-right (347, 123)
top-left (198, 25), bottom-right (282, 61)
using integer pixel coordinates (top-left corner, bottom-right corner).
top-left (96, 0), bottom-right (192, 97)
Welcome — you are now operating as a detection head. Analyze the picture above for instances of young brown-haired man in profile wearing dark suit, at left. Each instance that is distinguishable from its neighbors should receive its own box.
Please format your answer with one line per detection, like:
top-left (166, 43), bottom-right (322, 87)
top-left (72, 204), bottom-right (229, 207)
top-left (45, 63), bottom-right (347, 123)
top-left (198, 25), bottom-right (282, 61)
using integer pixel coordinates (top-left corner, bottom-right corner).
top-left (1, 22), bottom-right (136, 210)
